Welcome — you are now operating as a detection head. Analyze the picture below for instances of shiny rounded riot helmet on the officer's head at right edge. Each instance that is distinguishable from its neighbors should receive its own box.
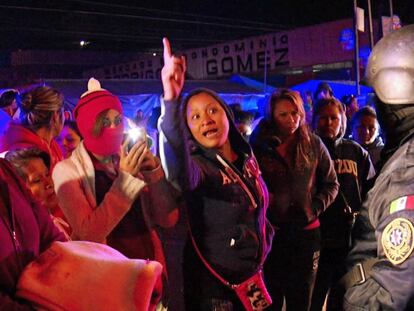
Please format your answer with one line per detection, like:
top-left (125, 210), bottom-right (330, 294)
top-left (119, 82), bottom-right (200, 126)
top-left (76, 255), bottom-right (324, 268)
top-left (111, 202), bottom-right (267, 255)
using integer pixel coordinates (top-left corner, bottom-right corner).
top-left (365, 24), bottom-right (414, 105)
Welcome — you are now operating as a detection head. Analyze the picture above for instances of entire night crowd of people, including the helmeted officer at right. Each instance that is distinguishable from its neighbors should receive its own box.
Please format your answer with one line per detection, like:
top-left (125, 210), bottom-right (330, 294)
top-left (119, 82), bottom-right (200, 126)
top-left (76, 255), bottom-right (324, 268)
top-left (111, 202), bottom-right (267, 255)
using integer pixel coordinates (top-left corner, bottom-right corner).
top-left (0, 26), bottom-right (414, 311)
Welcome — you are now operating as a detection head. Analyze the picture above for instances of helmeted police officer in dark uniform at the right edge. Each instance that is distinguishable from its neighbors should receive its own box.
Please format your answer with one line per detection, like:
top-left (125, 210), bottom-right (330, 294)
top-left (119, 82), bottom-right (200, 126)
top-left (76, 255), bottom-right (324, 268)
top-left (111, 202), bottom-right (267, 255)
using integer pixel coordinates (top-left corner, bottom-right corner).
top-left (342, 25), bottom-right (414, 310)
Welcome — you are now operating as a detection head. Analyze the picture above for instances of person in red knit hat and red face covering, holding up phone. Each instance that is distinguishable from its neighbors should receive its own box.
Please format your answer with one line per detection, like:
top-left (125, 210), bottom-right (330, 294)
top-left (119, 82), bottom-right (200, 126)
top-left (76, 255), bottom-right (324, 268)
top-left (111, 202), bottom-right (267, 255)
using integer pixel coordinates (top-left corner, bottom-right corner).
top-left (53, 79), bottom-right (178, 310)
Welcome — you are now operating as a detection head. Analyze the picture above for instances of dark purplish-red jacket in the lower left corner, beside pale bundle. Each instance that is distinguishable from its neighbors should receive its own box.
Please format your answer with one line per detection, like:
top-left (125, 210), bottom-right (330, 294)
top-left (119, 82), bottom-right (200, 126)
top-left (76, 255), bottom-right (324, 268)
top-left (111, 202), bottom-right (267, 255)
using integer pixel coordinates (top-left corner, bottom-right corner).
top-left (0, 159), bottom-right (65, 310)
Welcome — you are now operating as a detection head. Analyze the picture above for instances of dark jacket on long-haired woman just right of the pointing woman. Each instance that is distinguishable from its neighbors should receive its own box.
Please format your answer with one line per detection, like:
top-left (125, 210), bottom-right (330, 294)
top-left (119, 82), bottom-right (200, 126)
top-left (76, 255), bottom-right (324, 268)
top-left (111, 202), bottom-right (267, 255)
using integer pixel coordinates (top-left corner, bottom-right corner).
top-left (250, 119), bottom-right (339, 229)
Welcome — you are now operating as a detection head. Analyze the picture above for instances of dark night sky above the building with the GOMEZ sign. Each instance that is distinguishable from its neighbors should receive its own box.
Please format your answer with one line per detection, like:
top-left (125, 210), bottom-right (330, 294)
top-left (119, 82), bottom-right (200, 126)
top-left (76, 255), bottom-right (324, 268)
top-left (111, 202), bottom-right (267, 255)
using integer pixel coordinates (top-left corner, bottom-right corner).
top-left (0, 0), bottom-right (414, 53)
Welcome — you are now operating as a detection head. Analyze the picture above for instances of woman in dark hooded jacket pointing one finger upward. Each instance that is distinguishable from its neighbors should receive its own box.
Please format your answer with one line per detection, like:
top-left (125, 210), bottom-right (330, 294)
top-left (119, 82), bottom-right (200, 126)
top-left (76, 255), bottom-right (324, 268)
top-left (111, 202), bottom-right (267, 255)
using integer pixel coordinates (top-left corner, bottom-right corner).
top-left (160, 39), bottom-right (272, 311)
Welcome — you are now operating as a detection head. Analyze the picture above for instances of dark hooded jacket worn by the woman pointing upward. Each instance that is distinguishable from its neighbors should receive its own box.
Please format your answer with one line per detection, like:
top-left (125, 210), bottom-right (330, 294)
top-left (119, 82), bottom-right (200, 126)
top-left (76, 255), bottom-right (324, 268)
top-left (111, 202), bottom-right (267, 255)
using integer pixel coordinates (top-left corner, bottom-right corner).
top-left (159, 90), bottom-right (273, 283)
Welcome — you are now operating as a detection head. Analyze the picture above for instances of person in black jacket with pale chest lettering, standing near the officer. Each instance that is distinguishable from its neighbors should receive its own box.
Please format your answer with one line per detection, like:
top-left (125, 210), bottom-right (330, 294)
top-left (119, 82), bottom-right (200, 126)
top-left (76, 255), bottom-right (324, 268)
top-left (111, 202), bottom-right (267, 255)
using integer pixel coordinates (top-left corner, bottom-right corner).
top-left (311, 98), bottom-right (375, 311)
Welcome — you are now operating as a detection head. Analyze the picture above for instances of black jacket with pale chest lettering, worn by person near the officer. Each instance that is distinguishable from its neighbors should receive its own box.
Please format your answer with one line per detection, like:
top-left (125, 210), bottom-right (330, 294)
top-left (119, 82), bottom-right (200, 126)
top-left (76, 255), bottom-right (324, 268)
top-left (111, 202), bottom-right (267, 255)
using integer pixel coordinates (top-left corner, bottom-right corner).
top-left (319, 138), bottom-right (375, 247)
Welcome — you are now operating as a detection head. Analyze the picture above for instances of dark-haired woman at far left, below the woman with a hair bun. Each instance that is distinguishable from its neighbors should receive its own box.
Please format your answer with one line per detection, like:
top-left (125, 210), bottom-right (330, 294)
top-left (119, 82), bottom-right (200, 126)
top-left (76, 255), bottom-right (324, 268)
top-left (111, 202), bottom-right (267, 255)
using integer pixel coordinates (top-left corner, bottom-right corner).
top-left (6, 148), bottom-right (71, 240)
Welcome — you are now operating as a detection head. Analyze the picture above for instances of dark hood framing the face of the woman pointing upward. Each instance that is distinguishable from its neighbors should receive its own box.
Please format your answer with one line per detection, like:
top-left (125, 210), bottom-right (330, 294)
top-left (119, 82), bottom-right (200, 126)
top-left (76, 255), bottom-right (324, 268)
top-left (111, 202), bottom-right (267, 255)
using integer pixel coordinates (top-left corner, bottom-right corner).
top-left (181, 88), bottom-right (251, 158)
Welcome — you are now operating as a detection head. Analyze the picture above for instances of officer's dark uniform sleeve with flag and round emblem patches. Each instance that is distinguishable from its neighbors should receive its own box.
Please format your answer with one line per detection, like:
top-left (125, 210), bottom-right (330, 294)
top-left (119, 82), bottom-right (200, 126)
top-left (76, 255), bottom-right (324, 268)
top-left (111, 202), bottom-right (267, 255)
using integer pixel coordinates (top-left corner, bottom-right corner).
top-left (344, 137), bottom-right (414, 310)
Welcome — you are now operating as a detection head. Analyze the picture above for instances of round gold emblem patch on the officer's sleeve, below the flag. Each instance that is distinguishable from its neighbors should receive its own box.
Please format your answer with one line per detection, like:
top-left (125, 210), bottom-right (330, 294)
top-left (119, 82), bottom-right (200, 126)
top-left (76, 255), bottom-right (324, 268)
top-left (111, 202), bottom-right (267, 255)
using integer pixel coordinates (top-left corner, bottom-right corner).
top-left (381, 218), bottom-right (414, 265)
